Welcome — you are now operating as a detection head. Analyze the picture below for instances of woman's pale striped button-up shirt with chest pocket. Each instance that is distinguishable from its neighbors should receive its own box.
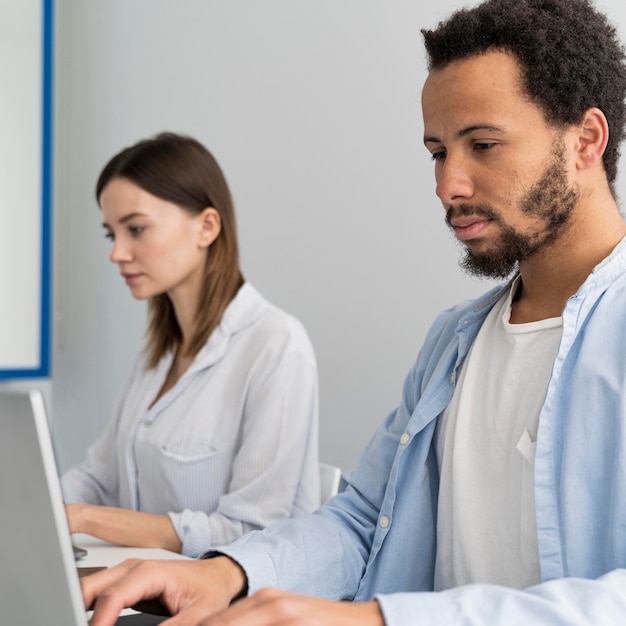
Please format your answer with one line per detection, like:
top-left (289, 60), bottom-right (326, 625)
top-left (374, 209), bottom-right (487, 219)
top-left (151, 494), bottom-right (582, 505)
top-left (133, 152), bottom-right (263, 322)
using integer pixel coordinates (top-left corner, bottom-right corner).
top-left (61, 283), bottom-right (319, 556)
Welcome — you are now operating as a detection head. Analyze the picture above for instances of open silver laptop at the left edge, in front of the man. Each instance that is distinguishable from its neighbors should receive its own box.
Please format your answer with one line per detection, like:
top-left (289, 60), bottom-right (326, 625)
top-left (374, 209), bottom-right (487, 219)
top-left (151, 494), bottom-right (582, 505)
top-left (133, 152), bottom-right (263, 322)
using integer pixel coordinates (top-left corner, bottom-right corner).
top-left (0, 390), bottom-right (166, 626)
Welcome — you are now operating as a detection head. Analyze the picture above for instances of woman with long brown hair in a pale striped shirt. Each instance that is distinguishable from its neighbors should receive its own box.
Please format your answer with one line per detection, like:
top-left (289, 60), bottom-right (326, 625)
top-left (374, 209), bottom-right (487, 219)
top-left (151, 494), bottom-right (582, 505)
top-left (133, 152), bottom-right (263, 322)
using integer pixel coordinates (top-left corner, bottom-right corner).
top-left (62, 133), bottom-right (319, 556)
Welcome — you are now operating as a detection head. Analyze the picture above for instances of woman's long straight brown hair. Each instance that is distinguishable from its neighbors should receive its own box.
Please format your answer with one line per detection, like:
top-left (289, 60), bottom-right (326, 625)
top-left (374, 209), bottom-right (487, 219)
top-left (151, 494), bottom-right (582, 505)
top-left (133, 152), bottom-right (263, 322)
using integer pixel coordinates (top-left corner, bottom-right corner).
top-left (96, 133), bottom-right (244, 369)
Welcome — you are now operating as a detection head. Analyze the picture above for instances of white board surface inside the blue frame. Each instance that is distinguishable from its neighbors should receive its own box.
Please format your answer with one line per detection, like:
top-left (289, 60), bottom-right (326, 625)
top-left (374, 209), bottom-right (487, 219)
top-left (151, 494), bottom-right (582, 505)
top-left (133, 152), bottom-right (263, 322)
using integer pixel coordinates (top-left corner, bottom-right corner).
top-left (0, 0), bottom-right (43, 372)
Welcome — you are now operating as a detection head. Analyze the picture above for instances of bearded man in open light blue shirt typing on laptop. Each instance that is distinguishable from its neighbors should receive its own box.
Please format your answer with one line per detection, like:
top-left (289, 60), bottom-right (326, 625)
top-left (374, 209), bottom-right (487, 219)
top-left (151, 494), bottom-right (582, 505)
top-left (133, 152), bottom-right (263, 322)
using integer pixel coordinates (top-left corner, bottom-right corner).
top-left (84, 0), bottom-right (626, 626)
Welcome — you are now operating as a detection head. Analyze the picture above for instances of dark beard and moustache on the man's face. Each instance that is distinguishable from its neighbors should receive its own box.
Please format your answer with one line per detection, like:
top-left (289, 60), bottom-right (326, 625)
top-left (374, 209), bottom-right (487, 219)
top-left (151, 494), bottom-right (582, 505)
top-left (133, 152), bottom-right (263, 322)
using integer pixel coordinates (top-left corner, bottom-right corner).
top-left (446, 147), bottom-right (578, 278)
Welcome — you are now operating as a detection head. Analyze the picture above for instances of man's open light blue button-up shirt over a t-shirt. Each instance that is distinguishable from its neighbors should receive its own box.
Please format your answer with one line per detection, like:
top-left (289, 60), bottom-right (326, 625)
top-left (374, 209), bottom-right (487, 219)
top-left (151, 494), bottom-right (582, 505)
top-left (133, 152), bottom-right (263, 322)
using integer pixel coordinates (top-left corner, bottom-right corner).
top-left (220, 241), bottom-right (626, 626)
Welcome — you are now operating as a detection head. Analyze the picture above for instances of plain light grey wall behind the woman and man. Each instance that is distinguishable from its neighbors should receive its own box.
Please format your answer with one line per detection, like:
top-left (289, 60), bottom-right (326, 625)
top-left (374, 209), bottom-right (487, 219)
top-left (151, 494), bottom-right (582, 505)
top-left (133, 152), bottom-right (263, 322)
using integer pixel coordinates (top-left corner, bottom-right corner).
top-left (53, 0), bottom-right (626, 467)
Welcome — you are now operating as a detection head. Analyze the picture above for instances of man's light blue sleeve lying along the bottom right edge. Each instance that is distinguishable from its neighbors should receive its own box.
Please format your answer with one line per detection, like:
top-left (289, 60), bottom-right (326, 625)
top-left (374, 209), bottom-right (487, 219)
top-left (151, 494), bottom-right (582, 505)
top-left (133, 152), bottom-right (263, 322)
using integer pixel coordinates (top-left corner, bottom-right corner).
top-left (376, 569), bottom-right (626, 626)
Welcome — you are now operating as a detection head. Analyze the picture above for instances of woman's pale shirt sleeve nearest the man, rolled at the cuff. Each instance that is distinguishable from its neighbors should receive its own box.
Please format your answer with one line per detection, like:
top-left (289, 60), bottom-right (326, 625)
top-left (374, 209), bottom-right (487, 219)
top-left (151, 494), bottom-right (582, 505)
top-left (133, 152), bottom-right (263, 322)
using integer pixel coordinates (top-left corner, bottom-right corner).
top-left (168, 350), bottom-right (320, 557)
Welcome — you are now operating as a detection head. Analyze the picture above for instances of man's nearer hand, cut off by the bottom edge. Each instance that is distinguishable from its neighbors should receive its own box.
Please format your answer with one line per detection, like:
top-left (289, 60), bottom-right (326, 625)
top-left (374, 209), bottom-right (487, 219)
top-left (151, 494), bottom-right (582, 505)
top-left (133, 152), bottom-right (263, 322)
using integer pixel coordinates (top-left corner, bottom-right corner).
top-left (196, 589), bottom-right (384, 626)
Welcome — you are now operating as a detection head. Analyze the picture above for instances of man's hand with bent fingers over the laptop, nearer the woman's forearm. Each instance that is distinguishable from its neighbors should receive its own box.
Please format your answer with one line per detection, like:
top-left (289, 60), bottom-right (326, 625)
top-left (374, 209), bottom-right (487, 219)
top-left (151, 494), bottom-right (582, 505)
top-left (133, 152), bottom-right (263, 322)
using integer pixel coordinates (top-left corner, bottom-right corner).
top-left (81, 557), bottom-right (246, 626)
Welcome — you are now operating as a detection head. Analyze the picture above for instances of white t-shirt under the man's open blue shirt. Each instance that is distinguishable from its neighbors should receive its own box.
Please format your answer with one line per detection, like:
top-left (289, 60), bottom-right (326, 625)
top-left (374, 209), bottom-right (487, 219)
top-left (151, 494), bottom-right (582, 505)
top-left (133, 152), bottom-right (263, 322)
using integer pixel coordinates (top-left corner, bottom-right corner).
top-left (435, 281), bottom-right (562, 590)
